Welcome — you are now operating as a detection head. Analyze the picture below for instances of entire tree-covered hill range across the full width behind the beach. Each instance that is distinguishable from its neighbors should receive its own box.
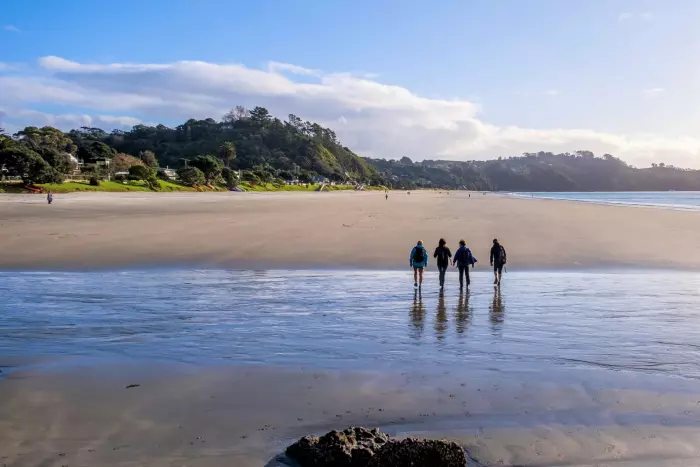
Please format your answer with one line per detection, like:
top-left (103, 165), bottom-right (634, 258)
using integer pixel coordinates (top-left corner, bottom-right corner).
top-left (0, 107), bottom-right (700, 191)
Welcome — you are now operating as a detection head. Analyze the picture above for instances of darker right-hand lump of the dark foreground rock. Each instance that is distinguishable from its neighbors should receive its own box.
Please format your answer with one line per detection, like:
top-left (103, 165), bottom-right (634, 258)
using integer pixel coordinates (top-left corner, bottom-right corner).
top-left (367, 438), bottom-right (467, 467)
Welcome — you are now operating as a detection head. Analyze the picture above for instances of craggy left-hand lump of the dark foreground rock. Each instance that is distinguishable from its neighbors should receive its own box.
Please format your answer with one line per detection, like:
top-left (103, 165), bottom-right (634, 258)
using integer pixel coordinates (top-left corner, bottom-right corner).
top-left (286, 427), bottom-right (389, 467)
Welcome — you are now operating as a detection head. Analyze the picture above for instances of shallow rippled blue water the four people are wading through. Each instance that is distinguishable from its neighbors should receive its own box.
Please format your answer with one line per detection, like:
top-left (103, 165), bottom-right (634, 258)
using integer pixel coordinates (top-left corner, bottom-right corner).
top-left (0, 270), bottom-right (700, 378)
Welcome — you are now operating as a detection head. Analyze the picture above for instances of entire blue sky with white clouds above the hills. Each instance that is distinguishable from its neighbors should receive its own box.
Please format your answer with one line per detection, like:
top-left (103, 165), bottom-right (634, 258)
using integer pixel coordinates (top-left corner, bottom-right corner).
top-left (0, 0), bottom-right (700, 168)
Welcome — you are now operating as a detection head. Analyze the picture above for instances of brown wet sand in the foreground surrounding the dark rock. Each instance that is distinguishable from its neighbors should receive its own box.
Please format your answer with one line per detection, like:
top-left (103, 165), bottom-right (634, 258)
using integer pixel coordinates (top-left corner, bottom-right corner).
top-left (0, 365), bottom-right (700, 467)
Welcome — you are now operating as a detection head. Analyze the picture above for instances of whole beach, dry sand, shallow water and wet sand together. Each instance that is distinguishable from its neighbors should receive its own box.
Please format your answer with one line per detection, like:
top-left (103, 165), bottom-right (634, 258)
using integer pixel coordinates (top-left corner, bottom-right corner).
top-left (0, 192), bottom-right (700, 467)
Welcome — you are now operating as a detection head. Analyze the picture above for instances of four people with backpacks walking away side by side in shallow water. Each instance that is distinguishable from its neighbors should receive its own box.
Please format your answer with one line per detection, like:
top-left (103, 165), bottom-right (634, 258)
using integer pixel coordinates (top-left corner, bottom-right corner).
top-left (410, 238), bottom-right (507, 290)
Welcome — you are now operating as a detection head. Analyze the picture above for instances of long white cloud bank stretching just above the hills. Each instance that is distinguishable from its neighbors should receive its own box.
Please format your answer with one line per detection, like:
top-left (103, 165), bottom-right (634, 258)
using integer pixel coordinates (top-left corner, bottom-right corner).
top-left (0, 57), bottom-right (700, 167)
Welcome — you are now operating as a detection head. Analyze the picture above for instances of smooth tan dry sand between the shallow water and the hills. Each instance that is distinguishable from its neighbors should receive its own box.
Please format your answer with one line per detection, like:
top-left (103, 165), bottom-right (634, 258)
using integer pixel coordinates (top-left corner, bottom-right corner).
top-left (0, 192), bottom-right (700, 269)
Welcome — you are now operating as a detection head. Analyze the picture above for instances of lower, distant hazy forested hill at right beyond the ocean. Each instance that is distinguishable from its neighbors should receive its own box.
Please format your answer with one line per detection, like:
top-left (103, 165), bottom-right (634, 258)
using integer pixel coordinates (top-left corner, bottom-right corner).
top-left (368, 151), bottom-right (700, 191)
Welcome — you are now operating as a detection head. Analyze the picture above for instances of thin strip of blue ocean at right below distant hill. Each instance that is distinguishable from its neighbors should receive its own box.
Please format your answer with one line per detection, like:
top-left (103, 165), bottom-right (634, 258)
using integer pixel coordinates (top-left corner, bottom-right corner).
top-left (512, 191), bottom-right (700, 211)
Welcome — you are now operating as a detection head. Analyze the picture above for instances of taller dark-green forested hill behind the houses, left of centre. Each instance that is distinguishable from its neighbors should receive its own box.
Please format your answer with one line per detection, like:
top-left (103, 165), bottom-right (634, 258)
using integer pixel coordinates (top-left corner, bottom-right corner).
top-left (68, 107), bottom-right (379, 182)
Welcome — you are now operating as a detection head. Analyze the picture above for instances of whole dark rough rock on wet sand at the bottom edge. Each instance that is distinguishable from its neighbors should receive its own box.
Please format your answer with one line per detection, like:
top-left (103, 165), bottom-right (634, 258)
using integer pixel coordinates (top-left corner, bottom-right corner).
top-left (286, 427), bottom-right (467, 467)
